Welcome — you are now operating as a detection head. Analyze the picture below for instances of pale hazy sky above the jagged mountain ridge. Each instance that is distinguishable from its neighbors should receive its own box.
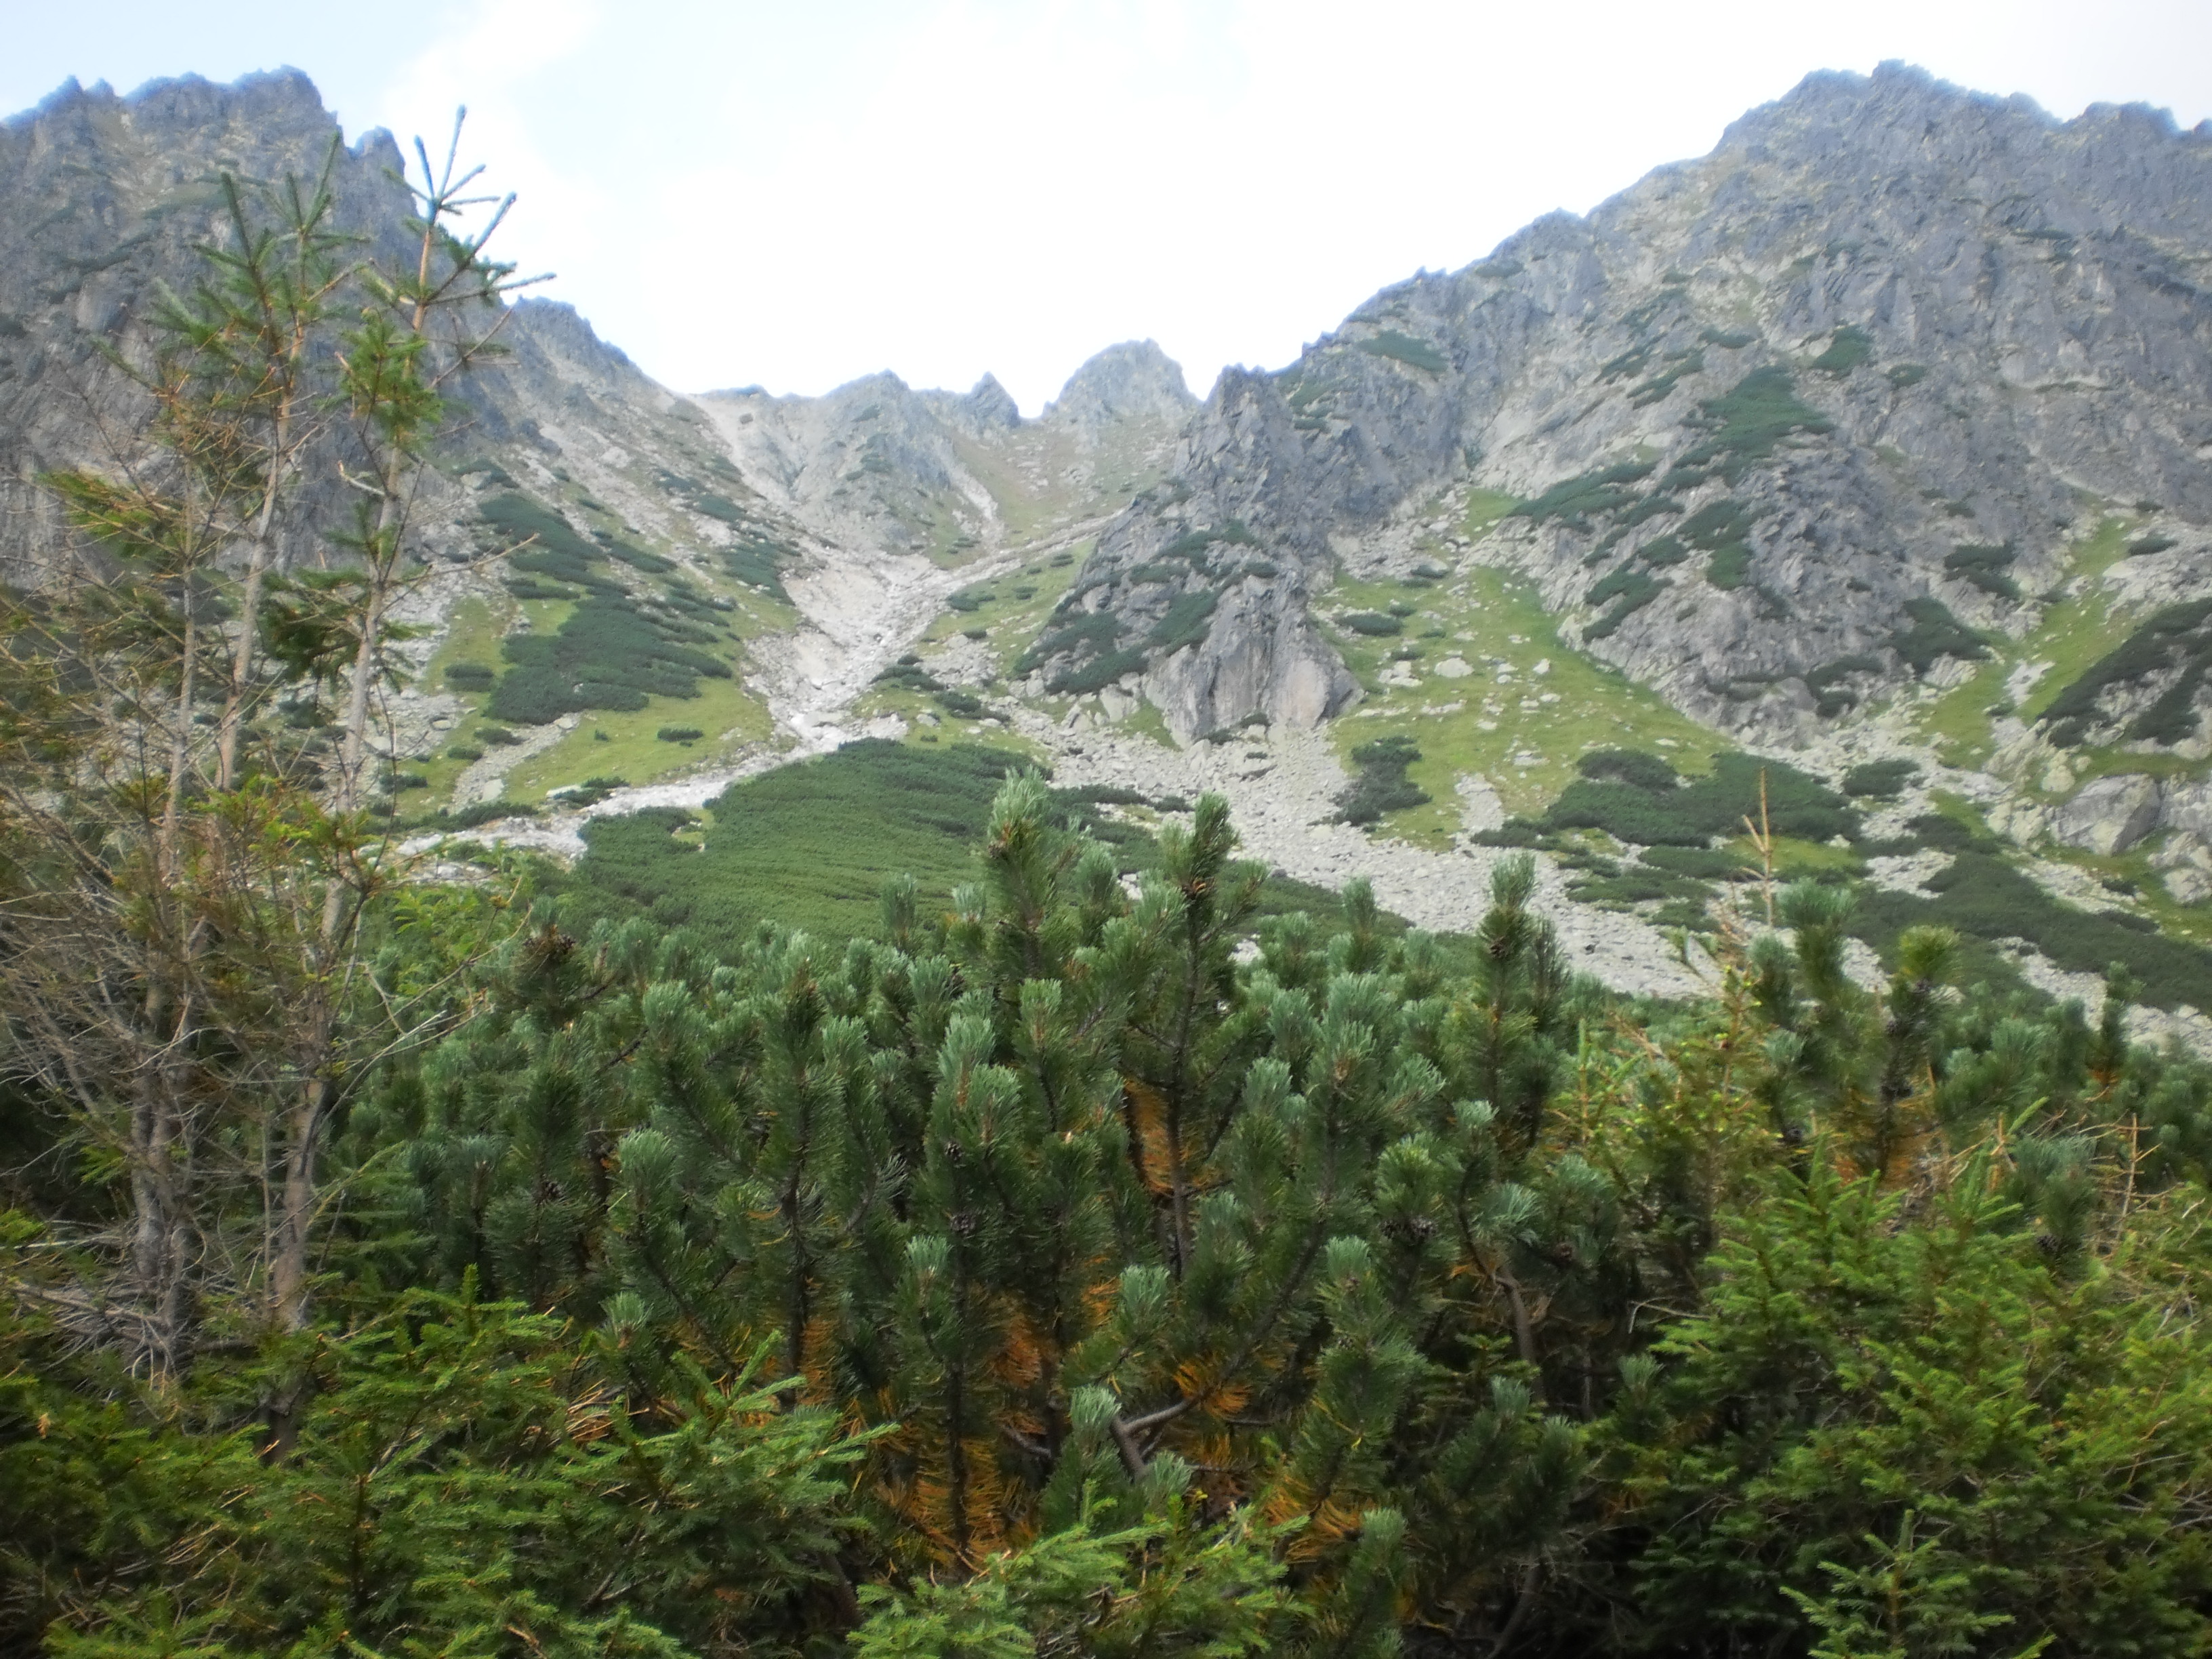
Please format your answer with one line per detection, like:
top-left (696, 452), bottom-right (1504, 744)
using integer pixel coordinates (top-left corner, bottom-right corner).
top-left (13, 0), bottom-right (2212, 411)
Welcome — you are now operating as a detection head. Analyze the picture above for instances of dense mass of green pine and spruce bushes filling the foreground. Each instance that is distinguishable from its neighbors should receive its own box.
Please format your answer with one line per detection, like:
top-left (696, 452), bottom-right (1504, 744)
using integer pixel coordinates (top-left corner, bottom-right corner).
top-left (13, 760), bottom-right (2212, 1659)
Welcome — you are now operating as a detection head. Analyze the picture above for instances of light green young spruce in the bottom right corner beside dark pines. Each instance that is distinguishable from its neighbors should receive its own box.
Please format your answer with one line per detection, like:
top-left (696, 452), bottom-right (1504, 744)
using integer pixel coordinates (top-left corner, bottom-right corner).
top-left (1622, 1139), bottom-right (2212, 1654)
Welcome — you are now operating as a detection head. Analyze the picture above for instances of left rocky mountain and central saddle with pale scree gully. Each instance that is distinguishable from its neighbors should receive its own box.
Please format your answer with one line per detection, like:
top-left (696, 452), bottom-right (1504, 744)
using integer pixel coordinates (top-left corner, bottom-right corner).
top-left (0, 70), bottom-right (1195, 805)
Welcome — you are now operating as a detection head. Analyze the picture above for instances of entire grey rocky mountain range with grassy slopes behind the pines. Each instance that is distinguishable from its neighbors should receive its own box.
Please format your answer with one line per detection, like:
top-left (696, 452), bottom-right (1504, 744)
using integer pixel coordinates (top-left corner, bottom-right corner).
top-left (0, 66), bottom-right (2212, 1046)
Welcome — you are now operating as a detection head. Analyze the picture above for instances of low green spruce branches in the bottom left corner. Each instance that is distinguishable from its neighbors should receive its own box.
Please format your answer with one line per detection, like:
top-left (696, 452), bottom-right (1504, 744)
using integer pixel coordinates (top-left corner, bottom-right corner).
top-left (9, 1288), bottom-right (863, 1659)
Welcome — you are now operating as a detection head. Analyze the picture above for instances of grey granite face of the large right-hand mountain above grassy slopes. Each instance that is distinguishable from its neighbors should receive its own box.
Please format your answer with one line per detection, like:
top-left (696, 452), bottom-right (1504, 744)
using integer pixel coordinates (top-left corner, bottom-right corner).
top-left (1035, 66), bottom-right (2212, 741)
